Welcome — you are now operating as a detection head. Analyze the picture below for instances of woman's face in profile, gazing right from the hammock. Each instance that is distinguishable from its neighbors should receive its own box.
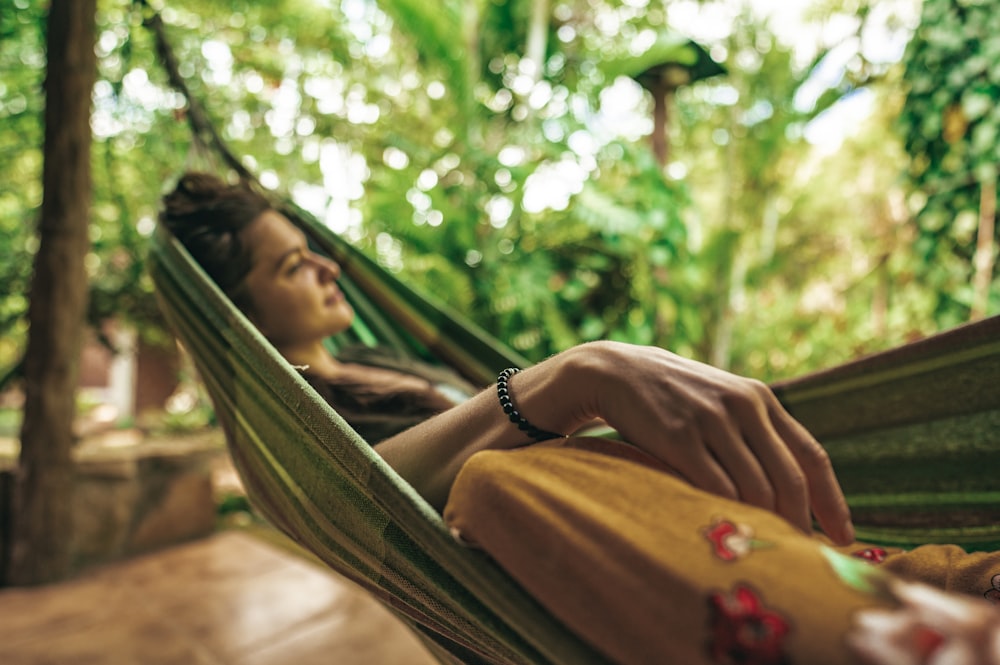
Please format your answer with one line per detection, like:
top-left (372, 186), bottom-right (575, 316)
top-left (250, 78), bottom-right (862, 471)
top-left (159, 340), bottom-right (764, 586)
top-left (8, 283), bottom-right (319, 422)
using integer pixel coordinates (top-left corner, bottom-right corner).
top-left (243, 210), bottom-right (354, 355)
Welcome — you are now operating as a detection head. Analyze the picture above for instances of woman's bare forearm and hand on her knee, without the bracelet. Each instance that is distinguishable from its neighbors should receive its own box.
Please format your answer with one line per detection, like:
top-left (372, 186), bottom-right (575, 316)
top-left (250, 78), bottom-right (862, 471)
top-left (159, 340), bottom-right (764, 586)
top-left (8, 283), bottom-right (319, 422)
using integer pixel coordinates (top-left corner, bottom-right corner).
top-left (376, 342), bottom-right (853, 543)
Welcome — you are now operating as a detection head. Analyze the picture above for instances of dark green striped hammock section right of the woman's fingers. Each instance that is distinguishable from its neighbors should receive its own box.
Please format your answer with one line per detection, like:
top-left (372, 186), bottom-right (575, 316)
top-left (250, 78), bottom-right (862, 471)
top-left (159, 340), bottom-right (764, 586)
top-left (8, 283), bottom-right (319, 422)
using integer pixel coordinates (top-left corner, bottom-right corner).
top-left (772, 317), bottom-right (1000, 550)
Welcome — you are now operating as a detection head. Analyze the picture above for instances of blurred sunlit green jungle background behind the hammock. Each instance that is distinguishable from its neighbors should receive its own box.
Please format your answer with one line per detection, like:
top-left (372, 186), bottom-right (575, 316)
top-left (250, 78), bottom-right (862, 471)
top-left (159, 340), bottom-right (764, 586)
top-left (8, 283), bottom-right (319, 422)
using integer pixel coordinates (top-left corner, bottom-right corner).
top-left (0, 0), bottom-right (1000, 380)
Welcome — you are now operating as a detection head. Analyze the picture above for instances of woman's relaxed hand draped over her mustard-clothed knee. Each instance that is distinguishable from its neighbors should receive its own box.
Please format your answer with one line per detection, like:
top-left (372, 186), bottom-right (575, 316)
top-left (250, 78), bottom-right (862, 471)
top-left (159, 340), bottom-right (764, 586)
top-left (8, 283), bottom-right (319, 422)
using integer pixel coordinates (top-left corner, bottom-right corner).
top-left (574, 342), bottom-right (854, 544)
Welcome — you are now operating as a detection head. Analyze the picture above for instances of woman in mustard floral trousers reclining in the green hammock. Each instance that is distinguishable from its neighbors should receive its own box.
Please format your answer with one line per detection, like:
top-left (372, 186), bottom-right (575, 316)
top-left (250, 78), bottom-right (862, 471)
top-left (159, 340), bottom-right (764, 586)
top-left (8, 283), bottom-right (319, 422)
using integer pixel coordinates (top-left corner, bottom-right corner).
top-left (161, 174), bottom-right (1000, 663)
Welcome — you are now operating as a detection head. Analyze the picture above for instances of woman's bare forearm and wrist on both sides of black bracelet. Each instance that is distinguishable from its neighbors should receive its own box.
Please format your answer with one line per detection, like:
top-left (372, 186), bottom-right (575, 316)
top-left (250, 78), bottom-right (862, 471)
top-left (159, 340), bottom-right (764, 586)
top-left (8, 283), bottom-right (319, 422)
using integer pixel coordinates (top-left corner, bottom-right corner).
top-left (375, 352), bottom-right (588, 509)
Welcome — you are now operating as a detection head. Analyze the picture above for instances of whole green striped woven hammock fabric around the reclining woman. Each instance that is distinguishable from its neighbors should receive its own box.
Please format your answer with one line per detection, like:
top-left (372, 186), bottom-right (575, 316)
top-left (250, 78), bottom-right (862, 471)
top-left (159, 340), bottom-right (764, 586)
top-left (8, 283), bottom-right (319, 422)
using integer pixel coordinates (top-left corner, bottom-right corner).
top-left (150, 204), bottom-right (1000, 664)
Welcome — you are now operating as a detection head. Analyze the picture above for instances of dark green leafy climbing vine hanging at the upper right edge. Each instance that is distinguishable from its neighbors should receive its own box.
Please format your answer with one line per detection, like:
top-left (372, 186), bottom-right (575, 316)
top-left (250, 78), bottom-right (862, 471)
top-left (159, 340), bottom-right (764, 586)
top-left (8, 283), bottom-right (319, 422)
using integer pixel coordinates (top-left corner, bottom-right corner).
top-left (900, 0), bottom-right (1000, 326)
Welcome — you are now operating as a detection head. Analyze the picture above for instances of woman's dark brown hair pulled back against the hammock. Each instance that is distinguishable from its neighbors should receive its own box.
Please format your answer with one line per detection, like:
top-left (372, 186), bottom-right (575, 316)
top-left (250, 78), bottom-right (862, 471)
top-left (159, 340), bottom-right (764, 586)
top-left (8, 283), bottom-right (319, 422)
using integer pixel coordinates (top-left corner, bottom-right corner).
top-left (160, 172), bottom-right (273, 312)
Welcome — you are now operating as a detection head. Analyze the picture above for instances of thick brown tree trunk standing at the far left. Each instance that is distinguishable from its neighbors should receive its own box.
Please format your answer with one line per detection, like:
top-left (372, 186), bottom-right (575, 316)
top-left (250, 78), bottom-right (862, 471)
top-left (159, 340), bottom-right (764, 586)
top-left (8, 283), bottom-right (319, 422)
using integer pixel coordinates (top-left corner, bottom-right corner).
top-left (8, 0), bottom-right (97, 585)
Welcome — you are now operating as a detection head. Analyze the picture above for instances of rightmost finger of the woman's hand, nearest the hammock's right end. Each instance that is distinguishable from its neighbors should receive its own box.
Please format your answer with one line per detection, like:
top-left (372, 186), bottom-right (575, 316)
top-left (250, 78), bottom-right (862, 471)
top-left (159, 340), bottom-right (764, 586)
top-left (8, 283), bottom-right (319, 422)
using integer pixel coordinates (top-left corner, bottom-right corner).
top-left (770, 403), bottom-right (854, 545)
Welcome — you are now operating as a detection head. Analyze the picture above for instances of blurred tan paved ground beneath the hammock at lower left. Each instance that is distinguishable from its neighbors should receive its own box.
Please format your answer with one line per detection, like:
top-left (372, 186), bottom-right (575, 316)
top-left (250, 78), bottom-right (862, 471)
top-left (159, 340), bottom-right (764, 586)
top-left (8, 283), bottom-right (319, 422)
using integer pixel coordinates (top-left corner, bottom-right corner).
top-left (0, 531), bottom-right (436, 665)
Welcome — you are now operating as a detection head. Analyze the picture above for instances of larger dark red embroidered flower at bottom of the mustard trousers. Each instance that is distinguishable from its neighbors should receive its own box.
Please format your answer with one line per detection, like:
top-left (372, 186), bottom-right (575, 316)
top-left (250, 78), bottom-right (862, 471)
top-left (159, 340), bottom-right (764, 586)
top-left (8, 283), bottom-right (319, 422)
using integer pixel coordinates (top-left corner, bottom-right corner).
top-left (708, 585), bottom-right (789, 665)
